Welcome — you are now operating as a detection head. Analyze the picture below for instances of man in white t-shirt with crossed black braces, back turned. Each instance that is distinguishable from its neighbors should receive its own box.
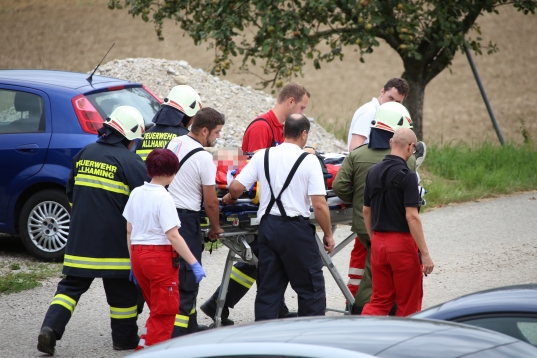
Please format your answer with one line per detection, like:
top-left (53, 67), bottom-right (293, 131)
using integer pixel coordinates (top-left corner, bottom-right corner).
top-left (222, 114), bottom-right (334, 321)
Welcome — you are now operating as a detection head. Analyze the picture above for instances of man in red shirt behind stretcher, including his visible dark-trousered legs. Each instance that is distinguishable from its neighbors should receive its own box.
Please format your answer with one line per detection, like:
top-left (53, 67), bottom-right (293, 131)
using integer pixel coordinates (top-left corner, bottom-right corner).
top-left (200, 82), bottom-right (310, 326)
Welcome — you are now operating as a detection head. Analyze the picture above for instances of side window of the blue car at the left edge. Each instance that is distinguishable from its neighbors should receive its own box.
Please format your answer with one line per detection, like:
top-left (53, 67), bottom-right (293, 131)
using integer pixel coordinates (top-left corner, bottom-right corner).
top-left (0, 89), bottom-right (45, 134)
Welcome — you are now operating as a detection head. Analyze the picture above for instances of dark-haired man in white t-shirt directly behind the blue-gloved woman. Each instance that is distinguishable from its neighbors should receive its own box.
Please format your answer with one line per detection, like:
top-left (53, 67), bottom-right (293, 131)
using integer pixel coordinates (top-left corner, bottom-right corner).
top-left (167, 108), bottom-right (225, 337)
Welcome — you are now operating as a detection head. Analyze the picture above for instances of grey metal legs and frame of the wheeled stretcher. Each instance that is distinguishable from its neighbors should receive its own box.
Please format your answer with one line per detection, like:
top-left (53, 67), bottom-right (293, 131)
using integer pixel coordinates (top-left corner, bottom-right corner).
top-left (201, 193), bottom-right (356, 327)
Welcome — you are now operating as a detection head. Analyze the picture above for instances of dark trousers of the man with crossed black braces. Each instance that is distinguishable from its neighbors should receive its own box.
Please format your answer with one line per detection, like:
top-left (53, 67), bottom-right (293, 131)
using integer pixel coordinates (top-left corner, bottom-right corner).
top-left (255, 215), bottom-right (326, 321)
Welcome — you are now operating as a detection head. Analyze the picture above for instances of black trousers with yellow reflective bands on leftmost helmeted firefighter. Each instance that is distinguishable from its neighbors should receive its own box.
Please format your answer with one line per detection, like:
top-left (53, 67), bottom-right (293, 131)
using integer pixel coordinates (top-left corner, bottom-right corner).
top-left (42, 276), bottom-right (139, 344)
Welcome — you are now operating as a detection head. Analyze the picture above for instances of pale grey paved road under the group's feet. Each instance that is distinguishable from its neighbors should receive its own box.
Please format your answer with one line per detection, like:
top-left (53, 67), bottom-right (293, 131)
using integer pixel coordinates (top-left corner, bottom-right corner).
top-left (0, 192), bottom-right (537, 357)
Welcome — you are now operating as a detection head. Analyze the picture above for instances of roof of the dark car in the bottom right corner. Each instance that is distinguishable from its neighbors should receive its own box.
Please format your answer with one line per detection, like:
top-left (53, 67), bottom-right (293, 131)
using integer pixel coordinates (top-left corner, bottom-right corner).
top-left (414, 284), bottom-right (537, 319)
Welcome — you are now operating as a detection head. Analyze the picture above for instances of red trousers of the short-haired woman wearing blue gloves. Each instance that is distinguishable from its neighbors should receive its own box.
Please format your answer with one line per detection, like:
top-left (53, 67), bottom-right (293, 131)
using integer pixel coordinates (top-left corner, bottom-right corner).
top-left (131, 245), bottom-right (179, 347)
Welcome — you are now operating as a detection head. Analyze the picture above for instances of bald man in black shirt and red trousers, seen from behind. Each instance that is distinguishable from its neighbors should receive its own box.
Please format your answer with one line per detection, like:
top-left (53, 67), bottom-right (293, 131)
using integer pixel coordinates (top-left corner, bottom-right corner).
top-left (362, 128), bottom-right (434, 316)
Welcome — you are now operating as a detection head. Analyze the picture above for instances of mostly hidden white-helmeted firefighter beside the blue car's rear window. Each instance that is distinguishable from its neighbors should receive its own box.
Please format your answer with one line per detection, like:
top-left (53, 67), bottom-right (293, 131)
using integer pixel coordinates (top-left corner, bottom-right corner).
top-left (136, 85), bottom-right (202, 162)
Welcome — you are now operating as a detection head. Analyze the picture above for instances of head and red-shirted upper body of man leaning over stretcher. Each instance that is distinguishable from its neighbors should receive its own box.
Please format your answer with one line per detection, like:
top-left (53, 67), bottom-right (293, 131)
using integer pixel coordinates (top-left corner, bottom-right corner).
top-left (242, 82), bottom-right (310, 153)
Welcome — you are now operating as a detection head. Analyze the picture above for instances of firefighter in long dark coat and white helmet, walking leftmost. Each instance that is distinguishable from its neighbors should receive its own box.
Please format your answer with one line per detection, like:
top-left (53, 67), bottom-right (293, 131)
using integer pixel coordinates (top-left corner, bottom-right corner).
top-left (37, 106), bottom-right (147, 355)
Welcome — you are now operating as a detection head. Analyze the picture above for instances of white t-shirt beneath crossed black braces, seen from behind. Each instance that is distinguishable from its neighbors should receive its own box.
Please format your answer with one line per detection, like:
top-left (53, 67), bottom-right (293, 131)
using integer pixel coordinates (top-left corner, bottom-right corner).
top-left (236, 143), bottom-right (326, 222)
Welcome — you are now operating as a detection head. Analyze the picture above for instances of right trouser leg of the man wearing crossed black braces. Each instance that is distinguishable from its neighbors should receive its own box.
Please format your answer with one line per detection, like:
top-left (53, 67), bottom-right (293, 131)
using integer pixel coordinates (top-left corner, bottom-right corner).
top-left (282, 219), bottom-right (326, 317)
